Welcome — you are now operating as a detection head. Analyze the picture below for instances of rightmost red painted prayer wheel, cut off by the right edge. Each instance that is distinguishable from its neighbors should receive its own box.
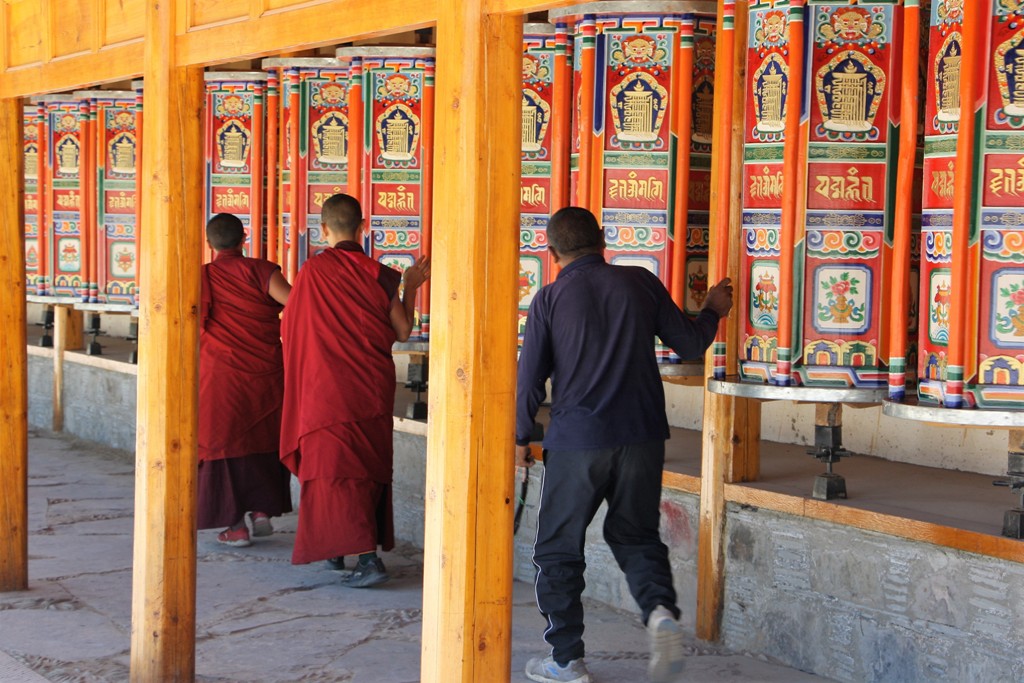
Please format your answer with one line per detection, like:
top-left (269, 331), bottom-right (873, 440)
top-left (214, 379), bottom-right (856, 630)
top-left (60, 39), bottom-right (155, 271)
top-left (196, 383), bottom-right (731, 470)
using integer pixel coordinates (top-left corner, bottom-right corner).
top-left (918, 0), bottom-right (1024, 411)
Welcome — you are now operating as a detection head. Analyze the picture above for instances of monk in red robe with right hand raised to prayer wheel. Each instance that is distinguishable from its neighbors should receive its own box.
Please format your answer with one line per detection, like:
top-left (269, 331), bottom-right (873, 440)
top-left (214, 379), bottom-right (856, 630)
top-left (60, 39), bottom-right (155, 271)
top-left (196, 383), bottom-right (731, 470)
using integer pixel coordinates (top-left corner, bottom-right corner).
top-left (281, 195), bottom-right (430, 588)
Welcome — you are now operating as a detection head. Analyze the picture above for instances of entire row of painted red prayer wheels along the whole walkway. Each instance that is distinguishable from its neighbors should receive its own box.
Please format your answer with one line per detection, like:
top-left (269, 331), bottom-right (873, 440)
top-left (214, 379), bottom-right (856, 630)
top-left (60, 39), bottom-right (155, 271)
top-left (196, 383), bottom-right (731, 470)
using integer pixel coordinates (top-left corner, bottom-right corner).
top-left (26, 0), bottom-right (1024, 409)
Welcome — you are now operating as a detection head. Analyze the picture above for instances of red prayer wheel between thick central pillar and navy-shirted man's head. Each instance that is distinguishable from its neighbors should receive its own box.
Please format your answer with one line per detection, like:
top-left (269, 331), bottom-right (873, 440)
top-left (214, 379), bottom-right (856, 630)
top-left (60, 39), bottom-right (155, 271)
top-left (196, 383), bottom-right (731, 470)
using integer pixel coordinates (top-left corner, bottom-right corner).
top-left (518, 24), bottom-right (572, 340)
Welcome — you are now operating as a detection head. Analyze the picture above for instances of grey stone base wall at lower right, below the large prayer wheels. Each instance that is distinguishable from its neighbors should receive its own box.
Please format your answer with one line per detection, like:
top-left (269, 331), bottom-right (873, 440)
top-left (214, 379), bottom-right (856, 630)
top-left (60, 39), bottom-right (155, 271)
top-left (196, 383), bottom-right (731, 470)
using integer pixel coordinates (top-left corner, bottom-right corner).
top-left (723, 505), bottom-right (1024, 683)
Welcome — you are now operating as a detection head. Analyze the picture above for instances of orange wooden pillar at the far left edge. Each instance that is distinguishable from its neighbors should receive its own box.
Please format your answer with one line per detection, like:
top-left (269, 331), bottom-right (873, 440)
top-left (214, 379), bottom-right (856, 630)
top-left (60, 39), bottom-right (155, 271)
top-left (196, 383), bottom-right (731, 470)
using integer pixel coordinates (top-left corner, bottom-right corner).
top-left (0, 98), bottom-right (29, 592)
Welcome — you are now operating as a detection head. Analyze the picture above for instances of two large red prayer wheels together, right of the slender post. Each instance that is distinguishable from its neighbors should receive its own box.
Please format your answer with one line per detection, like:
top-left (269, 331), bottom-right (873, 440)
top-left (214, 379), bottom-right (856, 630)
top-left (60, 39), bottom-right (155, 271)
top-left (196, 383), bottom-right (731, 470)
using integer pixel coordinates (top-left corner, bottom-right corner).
top-left (724, 0), bottom-right (1024, 410)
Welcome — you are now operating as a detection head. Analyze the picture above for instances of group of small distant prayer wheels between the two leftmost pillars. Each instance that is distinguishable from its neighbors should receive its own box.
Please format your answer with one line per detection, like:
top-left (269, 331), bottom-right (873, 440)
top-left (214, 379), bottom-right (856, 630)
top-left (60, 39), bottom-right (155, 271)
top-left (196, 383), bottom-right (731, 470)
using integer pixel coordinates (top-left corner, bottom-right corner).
top-left (24, 83), bottom-right (142, 305)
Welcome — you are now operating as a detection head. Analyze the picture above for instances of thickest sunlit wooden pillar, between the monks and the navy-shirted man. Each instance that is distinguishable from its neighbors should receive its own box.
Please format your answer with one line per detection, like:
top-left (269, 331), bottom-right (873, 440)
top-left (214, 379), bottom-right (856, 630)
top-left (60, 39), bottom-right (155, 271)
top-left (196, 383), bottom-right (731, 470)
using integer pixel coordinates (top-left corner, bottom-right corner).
top-left (422, 5), bottom-right (522, 683)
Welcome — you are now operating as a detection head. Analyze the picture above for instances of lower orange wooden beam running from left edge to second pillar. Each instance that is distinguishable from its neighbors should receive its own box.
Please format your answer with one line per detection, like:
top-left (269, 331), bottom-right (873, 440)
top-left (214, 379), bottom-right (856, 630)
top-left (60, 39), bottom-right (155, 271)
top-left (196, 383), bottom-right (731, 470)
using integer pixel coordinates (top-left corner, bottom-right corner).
top-left (0, 40), bottom-right (142, 97)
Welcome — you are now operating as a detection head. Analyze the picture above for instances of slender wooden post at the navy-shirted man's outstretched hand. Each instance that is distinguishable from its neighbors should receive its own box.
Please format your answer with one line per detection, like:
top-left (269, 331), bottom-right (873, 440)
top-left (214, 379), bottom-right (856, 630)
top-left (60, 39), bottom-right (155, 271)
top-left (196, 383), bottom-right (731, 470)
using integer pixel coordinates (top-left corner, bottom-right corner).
top-left (696, 0), bottom-right (761, 640)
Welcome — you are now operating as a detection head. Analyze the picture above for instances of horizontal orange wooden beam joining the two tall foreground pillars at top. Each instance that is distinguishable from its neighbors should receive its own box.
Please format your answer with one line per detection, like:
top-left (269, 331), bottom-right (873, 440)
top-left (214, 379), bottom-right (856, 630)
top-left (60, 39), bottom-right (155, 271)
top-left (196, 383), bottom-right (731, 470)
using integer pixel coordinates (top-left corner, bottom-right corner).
top-left (175, 0), bottom-right (440, 66)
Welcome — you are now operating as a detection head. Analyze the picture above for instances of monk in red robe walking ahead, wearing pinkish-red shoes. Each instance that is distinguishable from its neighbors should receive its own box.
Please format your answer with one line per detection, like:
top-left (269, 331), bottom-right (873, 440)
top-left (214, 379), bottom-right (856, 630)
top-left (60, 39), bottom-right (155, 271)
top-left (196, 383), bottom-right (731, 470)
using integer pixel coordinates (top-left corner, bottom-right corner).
top-left (199, 213), bottom-right (292, 547)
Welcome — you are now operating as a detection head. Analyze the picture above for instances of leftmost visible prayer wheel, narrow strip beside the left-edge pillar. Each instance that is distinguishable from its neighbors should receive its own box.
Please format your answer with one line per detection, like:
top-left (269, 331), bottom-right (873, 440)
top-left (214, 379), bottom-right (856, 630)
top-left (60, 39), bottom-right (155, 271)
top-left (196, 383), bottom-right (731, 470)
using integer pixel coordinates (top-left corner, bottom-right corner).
top-left (22, 104), bottom-right (46, 295)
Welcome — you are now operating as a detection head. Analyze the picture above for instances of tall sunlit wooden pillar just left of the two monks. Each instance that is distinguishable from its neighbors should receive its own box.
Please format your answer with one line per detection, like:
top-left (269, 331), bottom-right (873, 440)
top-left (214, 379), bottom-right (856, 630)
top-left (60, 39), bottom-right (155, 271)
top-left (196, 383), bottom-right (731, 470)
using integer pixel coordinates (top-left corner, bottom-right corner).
top-left (131, 0), bottom-right (204, 682)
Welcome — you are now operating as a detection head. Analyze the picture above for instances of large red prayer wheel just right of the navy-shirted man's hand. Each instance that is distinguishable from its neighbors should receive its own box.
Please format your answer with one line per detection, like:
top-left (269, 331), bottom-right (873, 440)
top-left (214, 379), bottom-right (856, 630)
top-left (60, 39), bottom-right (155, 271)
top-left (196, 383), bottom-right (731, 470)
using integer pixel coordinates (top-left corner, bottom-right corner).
top-left (738, 0), bottom-right (899, 387)
